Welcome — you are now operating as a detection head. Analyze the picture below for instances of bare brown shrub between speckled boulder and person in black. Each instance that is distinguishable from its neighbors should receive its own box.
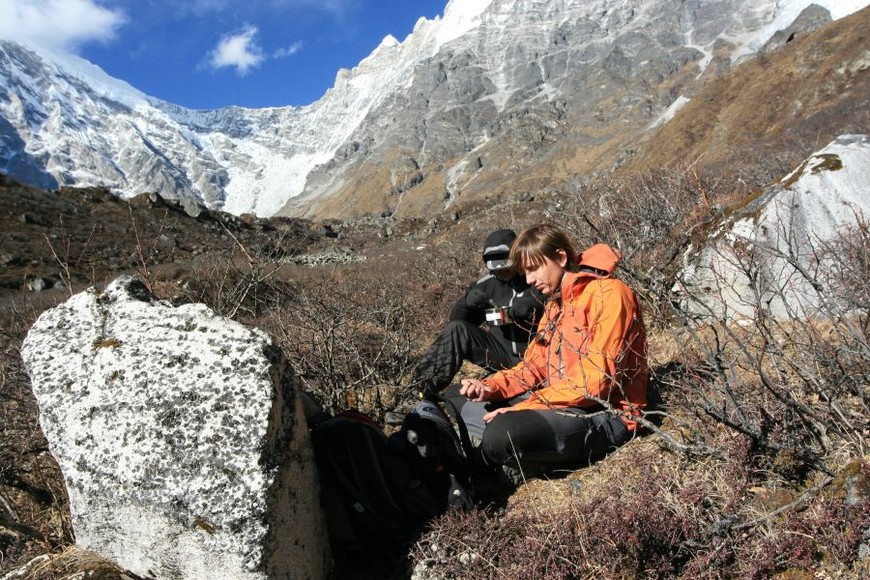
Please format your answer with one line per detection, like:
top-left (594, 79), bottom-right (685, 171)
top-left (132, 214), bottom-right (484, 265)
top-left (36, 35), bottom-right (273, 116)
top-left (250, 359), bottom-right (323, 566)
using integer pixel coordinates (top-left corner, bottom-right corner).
top-left (260, 238), bottom-right (480, 417)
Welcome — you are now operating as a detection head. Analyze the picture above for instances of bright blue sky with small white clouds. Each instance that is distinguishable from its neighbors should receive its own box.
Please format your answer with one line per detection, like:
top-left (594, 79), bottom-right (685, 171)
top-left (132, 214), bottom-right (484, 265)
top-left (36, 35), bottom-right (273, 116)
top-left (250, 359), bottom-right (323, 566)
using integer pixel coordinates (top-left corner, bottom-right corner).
top-left (0, 0), bottom-right (447, 109)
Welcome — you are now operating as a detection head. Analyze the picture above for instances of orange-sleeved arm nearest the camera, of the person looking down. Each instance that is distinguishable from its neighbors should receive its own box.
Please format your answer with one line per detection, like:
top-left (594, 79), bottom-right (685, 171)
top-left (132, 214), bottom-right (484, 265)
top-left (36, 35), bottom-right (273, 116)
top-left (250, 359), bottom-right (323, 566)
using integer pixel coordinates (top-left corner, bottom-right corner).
top-left (513, 283), bottom-right (635, 410)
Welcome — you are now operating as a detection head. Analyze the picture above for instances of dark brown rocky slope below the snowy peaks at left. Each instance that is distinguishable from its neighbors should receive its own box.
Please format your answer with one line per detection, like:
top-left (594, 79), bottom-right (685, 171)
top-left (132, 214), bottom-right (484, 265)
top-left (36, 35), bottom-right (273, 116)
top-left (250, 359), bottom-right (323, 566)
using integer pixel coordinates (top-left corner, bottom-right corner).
top-left (0, 176), bottom-right (327, 300)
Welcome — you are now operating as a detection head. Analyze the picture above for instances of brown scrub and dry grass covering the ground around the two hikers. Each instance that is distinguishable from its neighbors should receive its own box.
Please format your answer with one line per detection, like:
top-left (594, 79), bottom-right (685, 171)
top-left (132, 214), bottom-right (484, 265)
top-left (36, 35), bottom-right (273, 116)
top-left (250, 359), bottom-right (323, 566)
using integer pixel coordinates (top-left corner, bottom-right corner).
top-left (0, 147), bottom-right (870, 578)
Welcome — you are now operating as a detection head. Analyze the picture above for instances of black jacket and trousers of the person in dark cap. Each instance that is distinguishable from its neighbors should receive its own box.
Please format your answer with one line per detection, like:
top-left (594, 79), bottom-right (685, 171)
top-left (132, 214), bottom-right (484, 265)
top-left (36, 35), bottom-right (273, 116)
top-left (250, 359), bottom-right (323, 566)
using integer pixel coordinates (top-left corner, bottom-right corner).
top-left (412, 274), bottom-right (545, 394)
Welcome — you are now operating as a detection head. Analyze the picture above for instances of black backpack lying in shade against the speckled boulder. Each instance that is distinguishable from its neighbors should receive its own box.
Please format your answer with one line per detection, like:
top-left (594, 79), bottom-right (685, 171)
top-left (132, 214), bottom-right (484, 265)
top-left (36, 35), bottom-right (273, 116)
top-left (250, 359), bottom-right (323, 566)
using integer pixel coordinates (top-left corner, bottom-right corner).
top-left (311, 403), bottom-right (471, 553)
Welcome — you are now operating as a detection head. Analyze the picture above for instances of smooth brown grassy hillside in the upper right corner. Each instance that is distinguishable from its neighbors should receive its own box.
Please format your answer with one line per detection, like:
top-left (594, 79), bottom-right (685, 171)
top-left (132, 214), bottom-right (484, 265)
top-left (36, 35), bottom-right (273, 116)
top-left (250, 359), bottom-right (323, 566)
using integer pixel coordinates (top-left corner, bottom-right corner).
top-left (617, 8), bottom-right (870, 178)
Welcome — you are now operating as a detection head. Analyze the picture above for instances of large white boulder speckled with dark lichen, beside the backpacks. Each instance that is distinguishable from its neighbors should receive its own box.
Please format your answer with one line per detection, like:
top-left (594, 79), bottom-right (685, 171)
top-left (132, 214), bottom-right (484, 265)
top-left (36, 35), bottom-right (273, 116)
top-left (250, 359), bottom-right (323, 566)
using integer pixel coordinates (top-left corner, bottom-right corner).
top-left (21, 277), bottom-right (330, 579)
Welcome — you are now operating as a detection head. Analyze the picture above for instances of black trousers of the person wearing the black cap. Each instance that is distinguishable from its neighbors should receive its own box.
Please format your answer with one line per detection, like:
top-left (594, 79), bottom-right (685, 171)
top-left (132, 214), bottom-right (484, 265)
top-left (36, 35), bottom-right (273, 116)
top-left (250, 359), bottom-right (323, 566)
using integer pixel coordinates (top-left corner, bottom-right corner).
top-left (412, 320), bottom-right (520, 394)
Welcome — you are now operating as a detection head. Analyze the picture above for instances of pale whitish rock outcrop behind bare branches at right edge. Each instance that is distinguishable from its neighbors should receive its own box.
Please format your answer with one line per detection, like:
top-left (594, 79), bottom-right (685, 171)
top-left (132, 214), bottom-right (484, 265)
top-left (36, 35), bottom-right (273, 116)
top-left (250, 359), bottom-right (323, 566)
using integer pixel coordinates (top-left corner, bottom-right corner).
top-left (676, 135), bottom-right (870, 321)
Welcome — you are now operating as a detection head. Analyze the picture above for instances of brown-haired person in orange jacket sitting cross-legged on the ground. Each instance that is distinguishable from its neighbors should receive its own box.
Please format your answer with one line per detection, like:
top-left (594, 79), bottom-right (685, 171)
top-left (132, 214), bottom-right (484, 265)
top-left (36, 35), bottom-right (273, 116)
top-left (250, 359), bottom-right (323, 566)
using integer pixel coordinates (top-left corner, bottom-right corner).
top-left (459, 224), bottom-right (648, 483)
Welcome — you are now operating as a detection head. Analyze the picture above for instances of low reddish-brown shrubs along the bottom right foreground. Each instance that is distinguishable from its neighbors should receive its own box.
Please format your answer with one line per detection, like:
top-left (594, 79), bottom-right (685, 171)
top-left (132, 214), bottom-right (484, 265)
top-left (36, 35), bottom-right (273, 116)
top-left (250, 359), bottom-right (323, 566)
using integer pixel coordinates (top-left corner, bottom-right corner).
top-left (412, 442), bottom-right (870, 579)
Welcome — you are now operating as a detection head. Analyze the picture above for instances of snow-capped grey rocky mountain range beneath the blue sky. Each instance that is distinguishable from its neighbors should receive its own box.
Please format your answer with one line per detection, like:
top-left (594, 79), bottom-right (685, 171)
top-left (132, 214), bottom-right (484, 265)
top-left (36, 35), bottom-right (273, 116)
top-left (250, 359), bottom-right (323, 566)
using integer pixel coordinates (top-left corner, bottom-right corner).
top-left (0, 0), bottom-right (870, 217)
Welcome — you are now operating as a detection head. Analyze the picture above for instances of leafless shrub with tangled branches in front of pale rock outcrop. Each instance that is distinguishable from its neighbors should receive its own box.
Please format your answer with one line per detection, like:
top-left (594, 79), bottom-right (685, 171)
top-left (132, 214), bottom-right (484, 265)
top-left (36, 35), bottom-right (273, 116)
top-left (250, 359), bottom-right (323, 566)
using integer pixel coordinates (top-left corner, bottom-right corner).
top-left (672, 207), bottom-right (870, 466)
